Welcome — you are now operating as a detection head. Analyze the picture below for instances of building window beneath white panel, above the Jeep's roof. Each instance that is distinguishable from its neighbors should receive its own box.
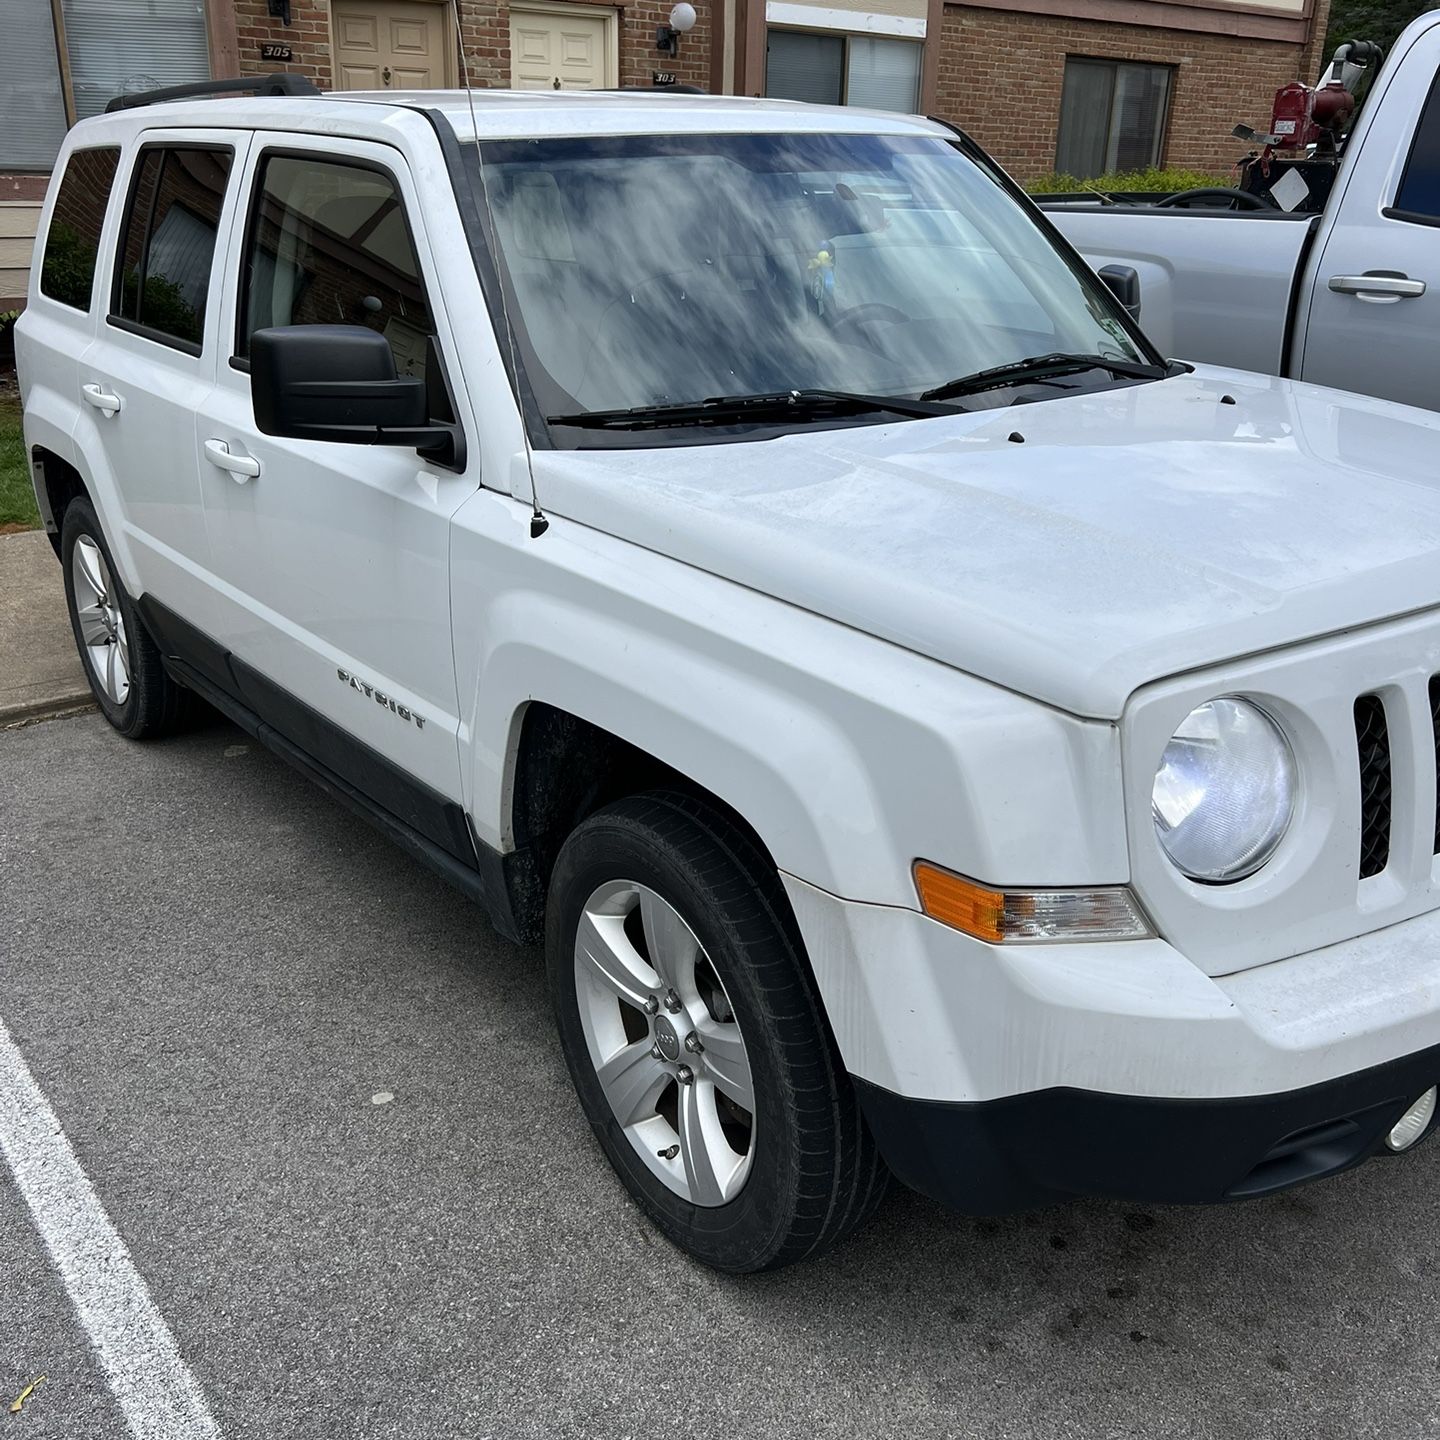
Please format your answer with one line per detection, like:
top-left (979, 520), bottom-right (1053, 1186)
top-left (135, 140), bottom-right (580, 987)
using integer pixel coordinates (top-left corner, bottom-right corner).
top-left (765, 30), bottom-right (922, 115)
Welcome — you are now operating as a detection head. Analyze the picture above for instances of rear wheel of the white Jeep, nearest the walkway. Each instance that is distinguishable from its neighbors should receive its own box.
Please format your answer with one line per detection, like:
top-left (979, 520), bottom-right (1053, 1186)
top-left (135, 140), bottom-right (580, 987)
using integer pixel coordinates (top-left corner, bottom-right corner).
top-left (60, 500), bottom-right (189, 740)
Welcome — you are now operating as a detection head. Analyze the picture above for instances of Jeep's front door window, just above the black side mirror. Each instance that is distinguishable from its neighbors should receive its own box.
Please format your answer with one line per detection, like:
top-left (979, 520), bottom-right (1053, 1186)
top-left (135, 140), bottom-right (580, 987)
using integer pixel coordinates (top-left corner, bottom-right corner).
top-left (236, 156), bottom-right (435, 376)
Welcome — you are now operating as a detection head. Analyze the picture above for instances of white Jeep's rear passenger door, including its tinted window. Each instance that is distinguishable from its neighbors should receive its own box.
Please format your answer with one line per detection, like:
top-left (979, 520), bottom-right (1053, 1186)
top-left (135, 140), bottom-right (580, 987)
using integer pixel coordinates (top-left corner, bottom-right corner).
top-left (75, 130), bottom-right (248, 615)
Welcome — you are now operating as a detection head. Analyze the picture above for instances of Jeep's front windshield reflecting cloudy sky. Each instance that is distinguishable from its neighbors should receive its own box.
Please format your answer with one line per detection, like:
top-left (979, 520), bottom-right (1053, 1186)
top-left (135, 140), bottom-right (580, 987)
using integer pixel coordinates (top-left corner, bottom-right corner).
top-left (466, 134), bottom-right (1153, 444)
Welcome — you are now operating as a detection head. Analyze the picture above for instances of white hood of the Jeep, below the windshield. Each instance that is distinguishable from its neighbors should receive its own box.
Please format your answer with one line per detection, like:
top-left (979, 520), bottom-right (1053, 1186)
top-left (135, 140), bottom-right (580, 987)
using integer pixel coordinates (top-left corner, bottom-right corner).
top-left (534, 367), bottom-right (1440, 719)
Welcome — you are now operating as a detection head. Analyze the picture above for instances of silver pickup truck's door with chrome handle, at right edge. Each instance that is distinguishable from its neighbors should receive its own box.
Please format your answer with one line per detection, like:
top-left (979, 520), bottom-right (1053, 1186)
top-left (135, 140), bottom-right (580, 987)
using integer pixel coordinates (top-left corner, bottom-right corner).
top-left (1295, 27), bottom-right (1440, 409)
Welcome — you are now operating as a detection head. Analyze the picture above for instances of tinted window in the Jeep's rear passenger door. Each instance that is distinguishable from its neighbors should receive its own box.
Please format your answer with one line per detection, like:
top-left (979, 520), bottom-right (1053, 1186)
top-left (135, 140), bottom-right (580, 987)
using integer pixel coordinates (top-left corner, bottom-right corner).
top-left (114, 145), bottom-right (230, 348)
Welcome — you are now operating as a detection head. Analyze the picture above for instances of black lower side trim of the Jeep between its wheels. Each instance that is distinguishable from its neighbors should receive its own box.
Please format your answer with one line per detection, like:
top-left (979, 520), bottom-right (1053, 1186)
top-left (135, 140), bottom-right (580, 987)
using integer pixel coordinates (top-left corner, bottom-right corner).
top-left (140, 595), bottom-right (536, 945)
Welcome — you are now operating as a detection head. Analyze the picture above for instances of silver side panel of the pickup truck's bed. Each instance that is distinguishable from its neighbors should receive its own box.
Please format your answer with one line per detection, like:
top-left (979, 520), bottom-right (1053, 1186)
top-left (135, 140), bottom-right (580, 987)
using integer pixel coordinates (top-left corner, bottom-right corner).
top-left (1041, 210), bottom-right (1320, 374)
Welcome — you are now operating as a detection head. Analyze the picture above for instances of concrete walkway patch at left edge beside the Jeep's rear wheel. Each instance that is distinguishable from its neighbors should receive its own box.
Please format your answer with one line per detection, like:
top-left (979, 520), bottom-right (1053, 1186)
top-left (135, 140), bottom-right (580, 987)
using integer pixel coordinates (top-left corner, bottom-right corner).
top-left (0, 530), bottom-right (94, 729)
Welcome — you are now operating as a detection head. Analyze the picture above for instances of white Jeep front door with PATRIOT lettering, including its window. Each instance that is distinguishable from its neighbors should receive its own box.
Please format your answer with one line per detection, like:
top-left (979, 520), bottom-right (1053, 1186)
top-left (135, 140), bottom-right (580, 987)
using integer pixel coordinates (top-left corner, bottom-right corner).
top-left (196, 134), bottom-right (478, 812)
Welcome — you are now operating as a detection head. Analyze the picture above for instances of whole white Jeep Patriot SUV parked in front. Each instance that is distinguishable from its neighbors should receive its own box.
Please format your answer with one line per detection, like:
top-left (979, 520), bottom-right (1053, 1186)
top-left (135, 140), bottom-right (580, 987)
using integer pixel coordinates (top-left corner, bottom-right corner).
top-left (17, 81), bottom-right (1440, 1270)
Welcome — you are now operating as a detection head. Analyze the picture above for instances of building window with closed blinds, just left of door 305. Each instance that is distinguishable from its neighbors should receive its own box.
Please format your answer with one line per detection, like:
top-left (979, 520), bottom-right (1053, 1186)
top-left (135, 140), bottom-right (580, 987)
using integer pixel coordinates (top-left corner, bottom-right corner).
top-left (61, 0), bottom-right (210, 120)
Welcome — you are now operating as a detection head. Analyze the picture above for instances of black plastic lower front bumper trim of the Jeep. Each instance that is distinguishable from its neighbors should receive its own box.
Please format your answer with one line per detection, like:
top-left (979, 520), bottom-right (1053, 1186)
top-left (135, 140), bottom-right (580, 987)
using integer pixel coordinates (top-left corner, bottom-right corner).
top-left (855, 1045), bottom-right (1440, 1215)
